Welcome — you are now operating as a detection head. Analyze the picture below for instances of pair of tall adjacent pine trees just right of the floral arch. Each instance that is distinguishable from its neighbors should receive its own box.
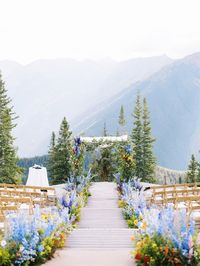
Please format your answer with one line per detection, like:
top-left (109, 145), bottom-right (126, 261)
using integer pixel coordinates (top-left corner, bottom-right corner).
top-left (131, 94), bottom-right (156, 182)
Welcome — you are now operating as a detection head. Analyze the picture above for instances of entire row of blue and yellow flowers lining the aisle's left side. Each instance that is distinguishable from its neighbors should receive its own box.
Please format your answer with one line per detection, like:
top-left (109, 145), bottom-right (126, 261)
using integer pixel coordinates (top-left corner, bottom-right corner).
top-left (0, 172), bottom-right (91, 266)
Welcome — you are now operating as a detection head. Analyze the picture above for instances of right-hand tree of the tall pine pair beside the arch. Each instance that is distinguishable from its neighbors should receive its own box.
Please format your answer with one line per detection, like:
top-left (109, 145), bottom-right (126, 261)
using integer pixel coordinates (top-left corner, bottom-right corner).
top-left (141, 98), bottom-right (155, 183)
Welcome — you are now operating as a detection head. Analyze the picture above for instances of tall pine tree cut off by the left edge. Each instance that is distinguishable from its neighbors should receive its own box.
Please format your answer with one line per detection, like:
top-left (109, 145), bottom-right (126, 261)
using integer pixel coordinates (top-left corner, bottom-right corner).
top-left (0, 74), bottom-right (20, 183)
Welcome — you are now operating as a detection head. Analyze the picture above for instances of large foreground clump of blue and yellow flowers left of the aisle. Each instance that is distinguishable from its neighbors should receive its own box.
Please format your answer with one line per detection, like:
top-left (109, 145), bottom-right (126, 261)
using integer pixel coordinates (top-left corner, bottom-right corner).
top-left (0, 207), bottom-right (72, 266)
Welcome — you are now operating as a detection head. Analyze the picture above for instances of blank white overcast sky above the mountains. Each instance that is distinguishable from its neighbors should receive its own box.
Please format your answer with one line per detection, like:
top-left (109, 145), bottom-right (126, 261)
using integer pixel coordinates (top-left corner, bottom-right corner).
top-left (0, 0), bottom-right (200, 63)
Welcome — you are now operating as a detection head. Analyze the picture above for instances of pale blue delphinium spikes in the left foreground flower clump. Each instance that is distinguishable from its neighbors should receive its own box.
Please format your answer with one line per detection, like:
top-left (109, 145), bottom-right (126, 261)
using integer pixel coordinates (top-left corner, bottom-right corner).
top-left (5, 203), bottom-right (71, 266)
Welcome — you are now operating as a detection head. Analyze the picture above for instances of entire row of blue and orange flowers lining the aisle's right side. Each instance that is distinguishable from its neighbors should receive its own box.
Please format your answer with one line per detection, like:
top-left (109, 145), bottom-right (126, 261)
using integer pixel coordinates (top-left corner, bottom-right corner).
top-left (117, 179), bottom-right (200, 266)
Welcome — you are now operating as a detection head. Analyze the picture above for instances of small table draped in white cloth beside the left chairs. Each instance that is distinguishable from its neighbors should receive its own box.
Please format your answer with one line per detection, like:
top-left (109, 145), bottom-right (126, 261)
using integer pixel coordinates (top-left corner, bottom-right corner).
top-left (26, 164), bottom-right (49, 187)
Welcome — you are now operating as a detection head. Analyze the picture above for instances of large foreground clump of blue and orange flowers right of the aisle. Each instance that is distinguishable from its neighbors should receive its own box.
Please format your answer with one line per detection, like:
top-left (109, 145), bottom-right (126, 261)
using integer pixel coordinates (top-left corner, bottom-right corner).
top-left (132, 206), bottom-right (200, 266)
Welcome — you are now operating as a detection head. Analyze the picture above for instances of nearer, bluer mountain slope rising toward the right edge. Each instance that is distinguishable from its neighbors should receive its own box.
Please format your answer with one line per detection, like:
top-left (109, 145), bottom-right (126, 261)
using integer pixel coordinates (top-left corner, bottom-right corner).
top-left (75, 53), bottom-right (200, 169)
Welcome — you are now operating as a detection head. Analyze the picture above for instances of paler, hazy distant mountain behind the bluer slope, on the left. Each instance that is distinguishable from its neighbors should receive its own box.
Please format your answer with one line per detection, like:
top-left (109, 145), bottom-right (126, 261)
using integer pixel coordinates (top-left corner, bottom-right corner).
top-left (0, 56), bottom-right (172, 157)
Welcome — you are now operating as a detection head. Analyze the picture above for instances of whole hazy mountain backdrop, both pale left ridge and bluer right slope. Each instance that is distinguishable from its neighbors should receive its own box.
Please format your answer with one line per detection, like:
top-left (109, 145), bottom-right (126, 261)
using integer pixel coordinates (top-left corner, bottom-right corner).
top-left (0, 53), bottom-right (200, 170)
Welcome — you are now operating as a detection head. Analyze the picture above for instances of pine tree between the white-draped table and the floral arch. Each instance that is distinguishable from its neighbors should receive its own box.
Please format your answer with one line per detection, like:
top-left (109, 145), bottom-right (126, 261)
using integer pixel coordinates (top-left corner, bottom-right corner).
top-left (51, 117), bottom-right (73, 184)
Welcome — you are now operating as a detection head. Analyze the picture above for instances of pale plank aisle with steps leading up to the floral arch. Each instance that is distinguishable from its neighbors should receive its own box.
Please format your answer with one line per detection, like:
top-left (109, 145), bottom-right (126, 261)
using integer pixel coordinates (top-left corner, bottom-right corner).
top-left (46, 182), bottom-right (134, 266)
